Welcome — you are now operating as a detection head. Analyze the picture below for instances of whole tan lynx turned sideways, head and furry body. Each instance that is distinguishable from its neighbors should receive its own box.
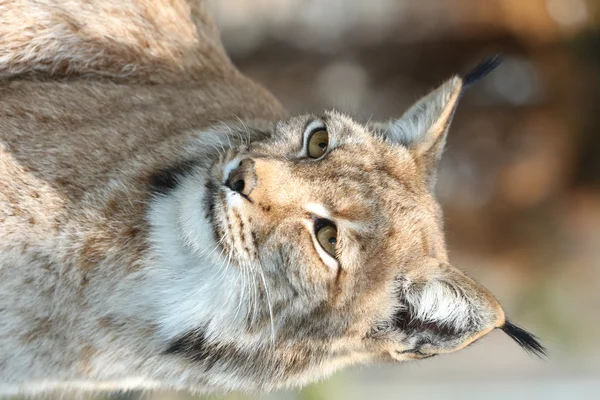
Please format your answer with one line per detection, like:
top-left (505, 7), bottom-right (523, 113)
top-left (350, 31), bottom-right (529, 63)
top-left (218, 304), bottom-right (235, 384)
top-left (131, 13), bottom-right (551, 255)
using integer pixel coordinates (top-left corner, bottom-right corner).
top-left (0, 0), bottom-right (544, 396)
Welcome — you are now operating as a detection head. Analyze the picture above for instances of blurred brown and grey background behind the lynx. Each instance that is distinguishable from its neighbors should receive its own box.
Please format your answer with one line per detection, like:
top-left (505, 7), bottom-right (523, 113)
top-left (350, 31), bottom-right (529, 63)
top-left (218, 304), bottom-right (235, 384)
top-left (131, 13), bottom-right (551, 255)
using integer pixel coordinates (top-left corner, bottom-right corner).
top-left (50, 0), bottom-right (600, 400)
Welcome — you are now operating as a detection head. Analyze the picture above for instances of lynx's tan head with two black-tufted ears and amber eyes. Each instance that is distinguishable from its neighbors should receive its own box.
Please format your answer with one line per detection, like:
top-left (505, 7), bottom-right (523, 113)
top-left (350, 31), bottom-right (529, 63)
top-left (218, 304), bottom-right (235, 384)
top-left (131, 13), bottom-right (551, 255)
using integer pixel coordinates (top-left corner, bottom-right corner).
top-left (154, 59), bottom-right (544, 388)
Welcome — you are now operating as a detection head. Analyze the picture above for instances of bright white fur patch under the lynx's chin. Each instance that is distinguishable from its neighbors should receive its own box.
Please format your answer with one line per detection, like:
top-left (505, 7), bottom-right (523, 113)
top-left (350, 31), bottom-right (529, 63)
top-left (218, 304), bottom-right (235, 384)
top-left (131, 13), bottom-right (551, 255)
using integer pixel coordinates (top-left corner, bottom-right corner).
top-left (148, 169), bottom-right (246, 338)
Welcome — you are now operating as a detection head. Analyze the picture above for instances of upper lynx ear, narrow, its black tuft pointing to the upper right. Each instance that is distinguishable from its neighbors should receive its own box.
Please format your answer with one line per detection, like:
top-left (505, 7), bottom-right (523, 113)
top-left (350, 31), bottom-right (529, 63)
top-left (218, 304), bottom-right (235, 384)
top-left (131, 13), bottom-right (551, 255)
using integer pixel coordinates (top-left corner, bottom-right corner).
top-left (370, 56), bottom-right (500, 188)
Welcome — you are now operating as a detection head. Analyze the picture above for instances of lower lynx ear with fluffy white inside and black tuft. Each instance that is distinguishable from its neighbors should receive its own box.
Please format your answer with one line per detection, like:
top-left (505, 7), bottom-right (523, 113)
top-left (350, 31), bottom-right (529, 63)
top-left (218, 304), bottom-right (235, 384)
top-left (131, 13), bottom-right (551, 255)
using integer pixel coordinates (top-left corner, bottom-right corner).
top-left (392, 259), bottom-right (545, 356)
